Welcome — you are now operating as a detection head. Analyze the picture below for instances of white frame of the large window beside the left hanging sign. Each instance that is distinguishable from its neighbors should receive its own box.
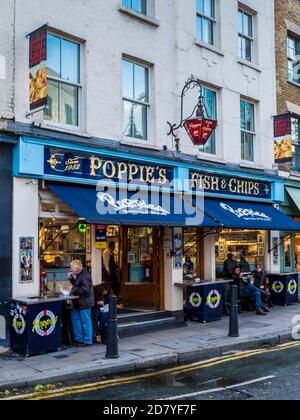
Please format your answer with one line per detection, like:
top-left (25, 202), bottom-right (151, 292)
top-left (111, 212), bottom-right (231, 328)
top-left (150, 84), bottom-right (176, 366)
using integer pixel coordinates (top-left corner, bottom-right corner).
top-left (43, 31), bottom-right (83, 132)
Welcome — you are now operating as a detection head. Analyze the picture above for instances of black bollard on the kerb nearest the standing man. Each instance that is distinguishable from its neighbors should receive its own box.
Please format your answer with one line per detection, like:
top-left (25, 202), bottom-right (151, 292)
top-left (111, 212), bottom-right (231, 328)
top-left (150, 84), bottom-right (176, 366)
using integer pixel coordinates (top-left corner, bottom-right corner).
top-left (105, 295), bottom-right (120, 359)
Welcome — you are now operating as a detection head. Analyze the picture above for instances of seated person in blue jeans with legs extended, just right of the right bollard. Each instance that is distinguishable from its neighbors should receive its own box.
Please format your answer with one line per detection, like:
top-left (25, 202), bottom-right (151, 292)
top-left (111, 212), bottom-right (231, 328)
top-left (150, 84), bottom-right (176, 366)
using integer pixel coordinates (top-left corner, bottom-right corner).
top-left (232, 265), bottom-right (267, 315)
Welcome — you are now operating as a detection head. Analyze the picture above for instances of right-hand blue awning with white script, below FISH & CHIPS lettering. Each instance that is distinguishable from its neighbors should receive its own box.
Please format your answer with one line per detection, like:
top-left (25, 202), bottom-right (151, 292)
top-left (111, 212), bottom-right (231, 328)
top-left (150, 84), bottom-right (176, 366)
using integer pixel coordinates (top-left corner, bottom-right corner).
top-left (204, 199), bottom-right (300, 232)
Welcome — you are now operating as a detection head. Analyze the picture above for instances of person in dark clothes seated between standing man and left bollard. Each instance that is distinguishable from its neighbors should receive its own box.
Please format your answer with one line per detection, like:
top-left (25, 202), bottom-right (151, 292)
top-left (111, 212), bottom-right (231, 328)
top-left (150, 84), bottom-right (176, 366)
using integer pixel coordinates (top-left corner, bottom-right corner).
top-left (93, 283), bottom-right (113, 344)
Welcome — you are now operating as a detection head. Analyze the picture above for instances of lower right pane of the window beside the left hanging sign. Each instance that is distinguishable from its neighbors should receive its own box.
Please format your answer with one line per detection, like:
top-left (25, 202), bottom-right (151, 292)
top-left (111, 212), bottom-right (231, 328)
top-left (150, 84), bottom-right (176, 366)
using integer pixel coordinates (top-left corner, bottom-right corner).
top-left (60, 83), bottom-right (78, 125)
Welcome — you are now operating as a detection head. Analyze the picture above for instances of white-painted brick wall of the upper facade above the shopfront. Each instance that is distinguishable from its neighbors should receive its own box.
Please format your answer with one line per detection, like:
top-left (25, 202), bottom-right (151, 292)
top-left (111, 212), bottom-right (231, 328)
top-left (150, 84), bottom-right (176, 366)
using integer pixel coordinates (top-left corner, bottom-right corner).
top-left (8, 0), bottom-right (276, 168)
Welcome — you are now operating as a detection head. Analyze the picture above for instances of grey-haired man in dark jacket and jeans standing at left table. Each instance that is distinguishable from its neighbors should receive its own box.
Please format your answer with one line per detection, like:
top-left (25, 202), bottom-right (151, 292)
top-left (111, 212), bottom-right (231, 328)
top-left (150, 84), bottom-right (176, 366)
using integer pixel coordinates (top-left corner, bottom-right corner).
top-left (68, 260), bottom-right (94, 347)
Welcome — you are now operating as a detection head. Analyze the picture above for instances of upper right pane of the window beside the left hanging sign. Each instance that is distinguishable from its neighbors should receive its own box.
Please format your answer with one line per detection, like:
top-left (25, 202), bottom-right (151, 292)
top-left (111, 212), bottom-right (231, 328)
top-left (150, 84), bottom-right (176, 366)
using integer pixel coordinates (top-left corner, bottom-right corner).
top-left (61, 39), bottom-right (80, 83)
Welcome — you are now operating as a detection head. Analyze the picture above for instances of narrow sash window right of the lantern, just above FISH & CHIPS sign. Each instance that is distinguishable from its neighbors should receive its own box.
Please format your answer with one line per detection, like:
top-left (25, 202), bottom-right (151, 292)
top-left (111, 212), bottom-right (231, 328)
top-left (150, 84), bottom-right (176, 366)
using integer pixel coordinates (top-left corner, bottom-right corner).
top-left (241, 100), bottom-right (256, 162)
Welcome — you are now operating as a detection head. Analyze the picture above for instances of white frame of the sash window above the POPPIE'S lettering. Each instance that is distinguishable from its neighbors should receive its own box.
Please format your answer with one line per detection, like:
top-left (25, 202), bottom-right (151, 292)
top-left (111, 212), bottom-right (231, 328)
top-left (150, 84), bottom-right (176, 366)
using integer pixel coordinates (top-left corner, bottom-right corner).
top-left (121, 56), bottom-right (152, 145)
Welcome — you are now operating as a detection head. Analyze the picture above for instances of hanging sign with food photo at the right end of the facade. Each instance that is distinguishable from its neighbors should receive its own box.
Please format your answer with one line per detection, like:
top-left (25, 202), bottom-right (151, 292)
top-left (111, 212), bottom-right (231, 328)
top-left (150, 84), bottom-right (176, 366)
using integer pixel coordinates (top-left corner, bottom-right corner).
top-left (274, 114), bottom-right (293, 163)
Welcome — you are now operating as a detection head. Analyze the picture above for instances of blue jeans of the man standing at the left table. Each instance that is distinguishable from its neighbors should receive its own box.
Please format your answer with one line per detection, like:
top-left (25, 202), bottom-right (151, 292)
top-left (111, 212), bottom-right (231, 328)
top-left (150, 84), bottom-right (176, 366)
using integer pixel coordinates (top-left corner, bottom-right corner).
top-left (71, 309), bottom-right (93, 345)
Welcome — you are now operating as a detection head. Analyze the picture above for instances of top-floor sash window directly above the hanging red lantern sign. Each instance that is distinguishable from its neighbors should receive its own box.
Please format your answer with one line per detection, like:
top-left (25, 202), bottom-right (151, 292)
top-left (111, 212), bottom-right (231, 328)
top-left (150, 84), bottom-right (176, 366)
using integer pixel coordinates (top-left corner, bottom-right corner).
top-left (197, 0), bottom-right (216, 45)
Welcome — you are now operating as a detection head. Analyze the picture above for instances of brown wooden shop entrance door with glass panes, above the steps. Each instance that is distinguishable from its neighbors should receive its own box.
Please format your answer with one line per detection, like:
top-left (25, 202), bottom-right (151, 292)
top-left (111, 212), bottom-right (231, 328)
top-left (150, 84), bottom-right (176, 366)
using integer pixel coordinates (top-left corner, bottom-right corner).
top-left (121, 227), bottom-right (164, 311)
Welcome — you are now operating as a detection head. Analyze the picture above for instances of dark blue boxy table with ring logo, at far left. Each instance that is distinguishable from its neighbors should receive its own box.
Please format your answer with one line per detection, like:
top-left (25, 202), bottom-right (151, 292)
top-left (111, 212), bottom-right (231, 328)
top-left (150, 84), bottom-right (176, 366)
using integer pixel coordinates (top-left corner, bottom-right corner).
top-left (10, 295), bottom-right (78, 356)
